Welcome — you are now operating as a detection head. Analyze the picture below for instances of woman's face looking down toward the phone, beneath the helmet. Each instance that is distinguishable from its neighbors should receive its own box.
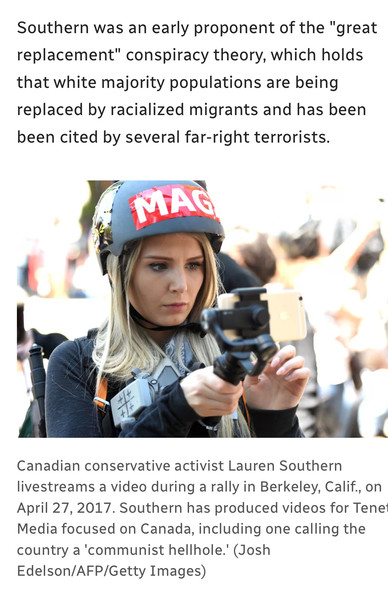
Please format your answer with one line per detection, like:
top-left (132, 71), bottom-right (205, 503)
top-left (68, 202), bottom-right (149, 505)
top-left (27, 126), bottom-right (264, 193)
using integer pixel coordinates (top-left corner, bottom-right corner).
top-left (128, 233), bottom-right (205, 326)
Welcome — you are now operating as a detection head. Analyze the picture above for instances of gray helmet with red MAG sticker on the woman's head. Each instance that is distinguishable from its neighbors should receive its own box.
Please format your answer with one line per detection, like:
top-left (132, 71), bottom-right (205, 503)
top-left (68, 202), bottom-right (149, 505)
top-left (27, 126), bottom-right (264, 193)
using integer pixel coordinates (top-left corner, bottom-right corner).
top-left (93, 180), bottom-right (225, 274)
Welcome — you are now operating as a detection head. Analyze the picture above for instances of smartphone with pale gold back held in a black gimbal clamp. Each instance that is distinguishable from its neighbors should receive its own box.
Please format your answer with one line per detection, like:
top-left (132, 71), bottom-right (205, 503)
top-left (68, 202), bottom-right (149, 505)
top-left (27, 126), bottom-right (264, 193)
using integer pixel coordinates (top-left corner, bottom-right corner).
top-left (218, 287), bottom-right (307, 342)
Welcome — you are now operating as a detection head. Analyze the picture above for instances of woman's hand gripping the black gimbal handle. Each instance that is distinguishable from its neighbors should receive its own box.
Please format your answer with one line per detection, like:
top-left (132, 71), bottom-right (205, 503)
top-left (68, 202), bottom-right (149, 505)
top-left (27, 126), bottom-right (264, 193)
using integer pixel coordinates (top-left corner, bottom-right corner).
top-left (181, 367), bottom-right (243, 417)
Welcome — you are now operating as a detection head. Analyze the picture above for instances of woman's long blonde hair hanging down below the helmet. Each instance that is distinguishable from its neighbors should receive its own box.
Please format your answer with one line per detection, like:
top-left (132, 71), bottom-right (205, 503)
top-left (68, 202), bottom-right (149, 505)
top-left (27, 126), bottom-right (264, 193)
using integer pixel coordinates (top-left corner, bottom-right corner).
top-left (93, 233), bottom-right (250, 437)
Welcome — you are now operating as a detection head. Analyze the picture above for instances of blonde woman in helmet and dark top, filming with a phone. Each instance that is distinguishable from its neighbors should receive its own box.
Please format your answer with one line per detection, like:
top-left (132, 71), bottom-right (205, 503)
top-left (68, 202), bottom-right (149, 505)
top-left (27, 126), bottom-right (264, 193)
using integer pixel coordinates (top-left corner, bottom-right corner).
top-left (46, 181), bottom-right (309, 437)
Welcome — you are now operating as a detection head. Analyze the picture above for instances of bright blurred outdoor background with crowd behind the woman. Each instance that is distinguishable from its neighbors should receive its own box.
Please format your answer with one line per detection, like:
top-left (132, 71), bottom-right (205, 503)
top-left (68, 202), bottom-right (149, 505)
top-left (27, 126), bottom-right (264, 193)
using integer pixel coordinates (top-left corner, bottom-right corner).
top-left (17, 178), bottom-right (388, 437)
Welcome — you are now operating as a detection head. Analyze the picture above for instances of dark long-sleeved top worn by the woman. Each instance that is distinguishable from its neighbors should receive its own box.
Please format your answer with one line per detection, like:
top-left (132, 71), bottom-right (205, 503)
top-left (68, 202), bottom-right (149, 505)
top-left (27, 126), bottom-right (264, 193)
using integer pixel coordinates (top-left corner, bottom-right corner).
top-left (46, 338), bottom-right (303, 437)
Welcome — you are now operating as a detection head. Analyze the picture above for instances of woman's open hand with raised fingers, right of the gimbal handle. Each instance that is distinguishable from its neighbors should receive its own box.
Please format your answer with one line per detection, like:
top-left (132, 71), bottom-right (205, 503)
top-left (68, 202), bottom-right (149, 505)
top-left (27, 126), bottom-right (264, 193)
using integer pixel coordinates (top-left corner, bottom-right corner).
top-left (244, 345), bottom-right (310, 410)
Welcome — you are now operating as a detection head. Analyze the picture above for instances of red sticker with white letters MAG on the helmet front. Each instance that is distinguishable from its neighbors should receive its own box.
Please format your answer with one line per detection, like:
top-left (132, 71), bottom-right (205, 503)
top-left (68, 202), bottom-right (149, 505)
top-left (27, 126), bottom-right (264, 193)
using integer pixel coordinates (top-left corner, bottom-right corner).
top-left (128, 185), bottom-right (220, 230)
